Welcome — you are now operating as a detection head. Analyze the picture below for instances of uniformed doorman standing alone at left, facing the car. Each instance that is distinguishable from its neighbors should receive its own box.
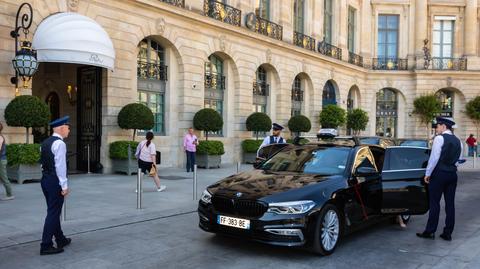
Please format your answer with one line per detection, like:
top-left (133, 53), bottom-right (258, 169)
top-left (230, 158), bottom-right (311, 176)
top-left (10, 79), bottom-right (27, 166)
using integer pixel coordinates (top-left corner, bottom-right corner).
top-left (40, 116), bottom-right (72, 255)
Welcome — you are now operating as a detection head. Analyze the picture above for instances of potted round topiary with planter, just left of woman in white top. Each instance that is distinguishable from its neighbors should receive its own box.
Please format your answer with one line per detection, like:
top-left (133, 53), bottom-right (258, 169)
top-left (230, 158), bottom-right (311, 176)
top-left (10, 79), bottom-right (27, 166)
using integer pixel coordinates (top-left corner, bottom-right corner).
top-left (109, 103), bottom-right (154, 175)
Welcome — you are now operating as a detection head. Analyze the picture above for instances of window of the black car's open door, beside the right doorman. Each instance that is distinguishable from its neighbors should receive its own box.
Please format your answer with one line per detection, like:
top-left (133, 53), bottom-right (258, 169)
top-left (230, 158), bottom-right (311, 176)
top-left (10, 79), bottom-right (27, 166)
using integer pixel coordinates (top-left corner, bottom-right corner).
top-left (387, 147), bottom-right (430, 170)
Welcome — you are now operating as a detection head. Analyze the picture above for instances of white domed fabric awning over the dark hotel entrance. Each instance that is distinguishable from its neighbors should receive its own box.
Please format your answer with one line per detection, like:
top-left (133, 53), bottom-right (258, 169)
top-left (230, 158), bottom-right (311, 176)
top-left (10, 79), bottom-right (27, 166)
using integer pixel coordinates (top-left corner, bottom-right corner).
top-left (32, 13), bottom-right (115, 70)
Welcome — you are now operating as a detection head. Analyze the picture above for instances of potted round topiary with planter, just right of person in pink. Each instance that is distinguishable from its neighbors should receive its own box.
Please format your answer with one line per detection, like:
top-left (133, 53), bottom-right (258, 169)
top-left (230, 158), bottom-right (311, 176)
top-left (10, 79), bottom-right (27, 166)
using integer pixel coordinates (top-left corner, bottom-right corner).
top-left (193, 108), bottom-right (225, 168)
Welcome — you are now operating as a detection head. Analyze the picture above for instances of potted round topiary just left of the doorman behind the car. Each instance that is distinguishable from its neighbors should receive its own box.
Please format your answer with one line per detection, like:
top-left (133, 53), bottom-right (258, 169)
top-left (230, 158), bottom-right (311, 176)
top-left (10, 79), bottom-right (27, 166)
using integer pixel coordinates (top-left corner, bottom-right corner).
top-left (242, 112), bottom-right (272, 163)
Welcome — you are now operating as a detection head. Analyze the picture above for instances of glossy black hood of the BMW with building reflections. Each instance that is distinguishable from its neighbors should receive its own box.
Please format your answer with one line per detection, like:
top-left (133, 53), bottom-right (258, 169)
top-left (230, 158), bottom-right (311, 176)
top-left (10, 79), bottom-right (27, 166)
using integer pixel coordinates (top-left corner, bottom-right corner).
top-left (208, 170), bottom-right (333, 199)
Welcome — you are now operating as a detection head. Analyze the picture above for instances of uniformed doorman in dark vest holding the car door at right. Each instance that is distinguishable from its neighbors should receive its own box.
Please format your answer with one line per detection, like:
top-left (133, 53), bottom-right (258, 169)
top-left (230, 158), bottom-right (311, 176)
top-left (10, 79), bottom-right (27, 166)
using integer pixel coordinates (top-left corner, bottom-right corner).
top-left (417, 117), bottom-right (462, 241)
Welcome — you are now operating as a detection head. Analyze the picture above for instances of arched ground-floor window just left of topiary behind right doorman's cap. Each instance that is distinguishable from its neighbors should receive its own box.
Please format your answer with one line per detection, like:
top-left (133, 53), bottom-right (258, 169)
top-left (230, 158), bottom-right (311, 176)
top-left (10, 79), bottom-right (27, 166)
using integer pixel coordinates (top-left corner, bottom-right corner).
top-left (376, 88), bottom-right (398, 137)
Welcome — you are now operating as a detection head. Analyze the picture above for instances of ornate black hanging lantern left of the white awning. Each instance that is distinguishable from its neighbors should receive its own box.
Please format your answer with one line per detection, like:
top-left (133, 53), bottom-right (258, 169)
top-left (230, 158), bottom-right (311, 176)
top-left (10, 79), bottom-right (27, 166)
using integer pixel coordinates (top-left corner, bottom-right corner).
top-left (12, 40), bottom-right (38, 88)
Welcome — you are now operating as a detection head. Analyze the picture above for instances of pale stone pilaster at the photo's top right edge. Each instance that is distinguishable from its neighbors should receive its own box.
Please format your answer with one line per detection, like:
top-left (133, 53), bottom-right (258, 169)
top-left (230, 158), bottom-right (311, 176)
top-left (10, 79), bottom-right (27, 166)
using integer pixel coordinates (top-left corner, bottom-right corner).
top-left (463, 0), bottom-right (478, 56)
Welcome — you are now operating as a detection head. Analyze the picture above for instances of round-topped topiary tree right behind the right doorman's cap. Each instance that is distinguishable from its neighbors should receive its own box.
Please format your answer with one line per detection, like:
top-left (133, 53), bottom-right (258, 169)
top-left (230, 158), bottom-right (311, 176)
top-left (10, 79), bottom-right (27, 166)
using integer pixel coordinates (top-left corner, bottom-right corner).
top-left (413, 94), bottom-right (442, 139)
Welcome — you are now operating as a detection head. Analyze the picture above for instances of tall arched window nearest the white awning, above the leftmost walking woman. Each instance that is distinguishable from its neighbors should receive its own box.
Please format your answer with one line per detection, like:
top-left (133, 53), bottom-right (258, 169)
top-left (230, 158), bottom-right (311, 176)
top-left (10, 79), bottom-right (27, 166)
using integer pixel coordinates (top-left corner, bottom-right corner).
top-left (137, 38), bottom-right (167, 135)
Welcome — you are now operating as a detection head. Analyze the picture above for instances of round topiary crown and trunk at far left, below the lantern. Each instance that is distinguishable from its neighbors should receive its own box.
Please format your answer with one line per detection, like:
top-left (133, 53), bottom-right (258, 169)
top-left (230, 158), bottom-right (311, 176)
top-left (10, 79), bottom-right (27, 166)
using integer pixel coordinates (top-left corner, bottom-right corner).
top-left (5, 95), bottom-right (50, 144)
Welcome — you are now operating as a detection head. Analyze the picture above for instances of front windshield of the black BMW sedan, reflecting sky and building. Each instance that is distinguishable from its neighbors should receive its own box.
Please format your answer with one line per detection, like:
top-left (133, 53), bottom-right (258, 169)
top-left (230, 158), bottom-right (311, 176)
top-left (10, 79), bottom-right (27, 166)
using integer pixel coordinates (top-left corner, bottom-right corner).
top-left (262, 147), bottom-right (351, 175)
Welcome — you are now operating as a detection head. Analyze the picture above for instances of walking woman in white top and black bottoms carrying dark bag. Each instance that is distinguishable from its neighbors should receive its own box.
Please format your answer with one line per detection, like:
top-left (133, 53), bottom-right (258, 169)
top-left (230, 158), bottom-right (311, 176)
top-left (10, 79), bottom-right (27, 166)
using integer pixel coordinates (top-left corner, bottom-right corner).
top-left (135, 132), bottom-right (167, 191)
